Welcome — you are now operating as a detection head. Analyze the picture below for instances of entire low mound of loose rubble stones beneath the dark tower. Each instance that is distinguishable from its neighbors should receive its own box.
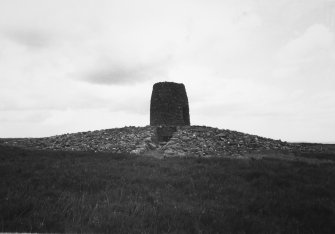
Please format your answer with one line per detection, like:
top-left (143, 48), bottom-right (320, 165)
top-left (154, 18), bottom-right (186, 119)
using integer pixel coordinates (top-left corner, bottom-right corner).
top-left (0, 126), bottom-right (323, 158)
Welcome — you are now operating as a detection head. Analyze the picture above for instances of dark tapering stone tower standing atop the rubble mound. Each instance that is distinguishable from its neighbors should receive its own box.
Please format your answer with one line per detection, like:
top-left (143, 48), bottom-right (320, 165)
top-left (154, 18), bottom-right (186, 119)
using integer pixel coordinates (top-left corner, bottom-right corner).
top-left (150, 82), bottom-right (190, 126)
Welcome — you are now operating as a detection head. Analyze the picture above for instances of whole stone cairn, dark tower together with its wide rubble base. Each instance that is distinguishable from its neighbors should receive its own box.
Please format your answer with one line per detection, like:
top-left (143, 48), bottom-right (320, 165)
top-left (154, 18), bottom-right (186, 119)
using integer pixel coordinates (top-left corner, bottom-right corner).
top-left (0, 82), bottom-right (324, 157)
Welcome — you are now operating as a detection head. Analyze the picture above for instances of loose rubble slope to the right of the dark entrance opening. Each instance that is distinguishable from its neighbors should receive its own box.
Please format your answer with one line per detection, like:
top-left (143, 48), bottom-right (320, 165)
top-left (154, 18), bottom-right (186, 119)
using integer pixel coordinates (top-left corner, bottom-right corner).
top-left (160, 126), bottom-right (315, 157)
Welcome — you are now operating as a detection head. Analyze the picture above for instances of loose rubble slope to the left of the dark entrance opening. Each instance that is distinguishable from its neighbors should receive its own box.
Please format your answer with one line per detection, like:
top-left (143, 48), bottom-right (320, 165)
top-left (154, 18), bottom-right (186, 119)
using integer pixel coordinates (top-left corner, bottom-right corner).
top-left (0, 126), bottom-right (155, 153)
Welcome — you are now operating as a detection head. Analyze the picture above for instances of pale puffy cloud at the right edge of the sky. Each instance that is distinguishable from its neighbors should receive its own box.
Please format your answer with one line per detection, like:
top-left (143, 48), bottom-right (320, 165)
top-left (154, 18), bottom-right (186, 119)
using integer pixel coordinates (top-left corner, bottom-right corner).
top-left (272, 24), bottom-right (335, 90)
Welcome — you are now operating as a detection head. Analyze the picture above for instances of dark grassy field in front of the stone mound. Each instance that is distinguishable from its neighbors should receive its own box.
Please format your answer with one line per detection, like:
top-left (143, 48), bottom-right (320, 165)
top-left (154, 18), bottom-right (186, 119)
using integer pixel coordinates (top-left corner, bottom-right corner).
top-left (0, 146), bottom-right (335, 233)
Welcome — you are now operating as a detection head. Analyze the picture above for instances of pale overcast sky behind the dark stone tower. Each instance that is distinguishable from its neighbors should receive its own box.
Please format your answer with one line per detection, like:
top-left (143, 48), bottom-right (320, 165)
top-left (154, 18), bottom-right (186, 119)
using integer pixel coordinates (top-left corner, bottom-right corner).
top-left (0, 0), bottom-right (335, 142)
